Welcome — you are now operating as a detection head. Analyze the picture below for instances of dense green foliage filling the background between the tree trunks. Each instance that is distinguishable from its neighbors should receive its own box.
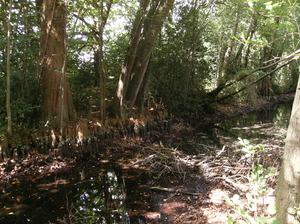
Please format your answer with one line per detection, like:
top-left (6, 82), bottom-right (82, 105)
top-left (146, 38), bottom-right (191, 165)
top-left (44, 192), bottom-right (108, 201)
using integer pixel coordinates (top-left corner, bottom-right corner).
top-left (0, 0), bottom-right (299, 131)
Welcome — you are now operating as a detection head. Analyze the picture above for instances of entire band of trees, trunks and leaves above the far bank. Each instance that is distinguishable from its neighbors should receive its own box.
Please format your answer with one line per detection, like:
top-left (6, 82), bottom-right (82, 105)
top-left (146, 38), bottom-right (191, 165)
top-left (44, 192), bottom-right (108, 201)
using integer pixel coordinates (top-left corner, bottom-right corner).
top-left (0, 0), bottom-right (300, 129)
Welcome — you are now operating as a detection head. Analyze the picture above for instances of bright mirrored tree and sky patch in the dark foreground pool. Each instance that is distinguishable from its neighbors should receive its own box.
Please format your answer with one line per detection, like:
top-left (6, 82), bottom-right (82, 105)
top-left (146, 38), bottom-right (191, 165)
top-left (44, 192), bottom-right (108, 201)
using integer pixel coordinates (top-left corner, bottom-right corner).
top-left (74, 170), bottom-right (128, 224)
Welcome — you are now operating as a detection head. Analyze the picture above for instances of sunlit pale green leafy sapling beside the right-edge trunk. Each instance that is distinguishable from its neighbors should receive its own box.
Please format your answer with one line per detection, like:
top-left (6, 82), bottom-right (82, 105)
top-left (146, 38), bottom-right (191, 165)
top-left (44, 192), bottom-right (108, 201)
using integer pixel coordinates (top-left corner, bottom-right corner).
top-left (224, 139), bottom-right (280, 224)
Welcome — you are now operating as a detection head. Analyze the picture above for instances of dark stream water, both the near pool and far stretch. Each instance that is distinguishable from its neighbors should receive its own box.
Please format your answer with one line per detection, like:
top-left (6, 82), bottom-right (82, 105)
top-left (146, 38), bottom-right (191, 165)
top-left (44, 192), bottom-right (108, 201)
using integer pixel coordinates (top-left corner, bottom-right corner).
top-left (0, 103), bottom-right (292, 223)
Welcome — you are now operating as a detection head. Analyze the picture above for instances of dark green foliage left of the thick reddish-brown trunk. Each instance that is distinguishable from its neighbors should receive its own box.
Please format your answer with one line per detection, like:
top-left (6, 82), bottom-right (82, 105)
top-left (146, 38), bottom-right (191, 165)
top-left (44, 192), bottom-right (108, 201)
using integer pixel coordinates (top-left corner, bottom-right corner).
top-left (0, 1), bottom-right (40, 128)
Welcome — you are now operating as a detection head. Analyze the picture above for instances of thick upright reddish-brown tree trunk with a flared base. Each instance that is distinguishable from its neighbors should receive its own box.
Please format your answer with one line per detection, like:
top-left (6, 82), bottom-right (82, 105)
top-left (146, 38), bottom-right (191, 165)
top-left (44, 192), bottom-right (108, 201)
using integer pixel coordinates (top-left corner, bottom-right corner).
top-left (40, 0), bottom-right (75, 126)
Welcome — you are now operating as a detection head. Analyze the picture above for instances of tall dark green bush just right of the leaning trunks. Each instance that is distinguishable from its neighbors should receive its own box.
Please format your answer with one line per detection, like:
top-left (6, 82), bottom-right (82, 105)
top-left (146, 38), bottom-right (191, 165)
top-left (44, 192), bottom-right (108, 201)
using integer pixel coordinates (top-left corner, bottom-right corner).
top-left (147, 2), bottom-right (210, 113)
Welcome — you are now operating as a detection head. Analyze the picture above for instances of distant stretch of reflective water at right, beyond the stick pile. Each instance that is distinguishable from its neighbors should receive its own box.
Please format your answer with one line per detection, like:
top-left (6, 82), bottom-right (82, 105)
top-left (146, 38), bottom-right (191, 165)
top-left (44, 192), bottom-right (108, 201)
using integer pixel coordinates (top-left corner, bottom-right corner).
top-left (178, 102), bottom-right (293, 155)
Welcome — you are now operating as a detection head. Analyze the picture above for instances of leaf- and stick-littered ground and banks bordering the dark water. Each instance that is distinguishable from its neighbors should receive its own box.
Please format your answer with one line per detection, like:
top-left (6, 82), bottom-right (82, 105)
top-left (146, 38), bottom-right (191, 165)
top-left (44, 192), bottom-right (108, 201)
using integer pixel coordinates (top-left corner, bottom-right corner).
top-left (0, 94), bottom-right (294, 223)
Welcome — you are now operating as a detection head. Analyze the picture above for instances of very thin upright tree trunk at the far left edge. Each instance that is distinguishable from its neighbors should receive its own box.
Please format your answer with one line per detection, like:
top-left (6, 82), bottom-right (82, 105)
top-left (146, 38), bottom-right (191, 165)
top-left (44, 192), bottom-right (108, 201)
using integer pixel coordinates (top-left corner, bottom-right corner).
top-left (1, 0), bottom-right (12, 136)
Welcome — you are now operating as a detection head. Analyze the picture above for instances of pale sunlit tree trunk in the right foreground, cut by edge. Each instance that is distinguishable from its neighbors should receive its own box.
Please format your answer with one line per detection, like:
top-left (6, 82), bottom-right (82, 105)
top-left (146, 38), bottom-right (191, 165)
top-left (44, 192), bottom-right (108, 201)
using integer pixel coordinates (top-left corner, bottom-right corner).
top-left (276, 73), bottom-right (300, 224)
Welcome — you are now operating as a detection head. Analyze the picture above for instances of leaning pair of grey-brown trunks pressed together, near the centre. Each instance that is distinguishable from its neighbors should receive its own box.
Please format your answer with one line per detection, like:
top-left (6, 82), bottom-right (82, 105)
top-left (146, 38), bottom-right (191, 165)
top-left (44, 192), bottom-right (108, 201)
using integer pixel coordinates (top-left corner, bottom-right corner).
top-left (114, 0), bottom-right (174, 118)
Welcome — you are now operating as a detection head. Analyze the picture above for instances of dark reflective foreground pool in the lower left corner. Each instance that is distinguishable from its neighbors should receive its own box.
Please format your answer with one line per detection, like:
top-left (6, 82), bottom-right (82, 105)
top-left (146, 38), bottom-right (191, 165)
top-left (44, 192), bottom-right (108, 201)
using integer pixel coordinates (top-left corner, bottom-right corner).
top-left (0, 166), bottom-right (130, 224)
